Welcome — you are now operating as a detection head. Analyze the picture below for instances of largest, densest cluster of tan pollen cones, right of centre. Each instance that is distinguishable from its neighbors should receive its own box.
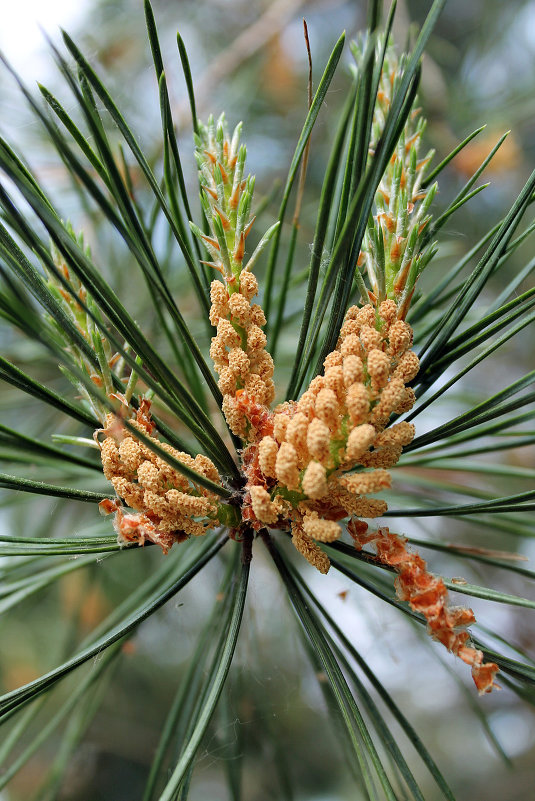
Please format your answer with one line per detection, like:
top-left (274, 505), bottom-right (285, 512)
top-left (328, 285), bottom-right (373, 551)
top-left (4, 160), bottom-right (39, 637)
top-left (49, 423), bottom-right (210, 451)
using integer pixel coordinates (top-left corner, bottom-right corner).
top-left (243, 300), bottom-right (418, 573)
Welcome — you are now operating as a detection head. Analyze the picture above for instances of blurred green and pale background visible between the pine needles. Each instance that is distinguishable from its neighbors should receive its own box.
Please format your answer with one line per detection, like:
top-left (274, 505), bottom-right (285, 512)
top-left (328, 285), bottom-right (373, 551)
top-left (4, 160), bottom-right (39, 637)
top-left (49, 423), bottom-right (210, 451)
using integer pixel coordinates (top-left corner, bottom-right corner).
top-left (0, 0), bottom-right (535, 801)
